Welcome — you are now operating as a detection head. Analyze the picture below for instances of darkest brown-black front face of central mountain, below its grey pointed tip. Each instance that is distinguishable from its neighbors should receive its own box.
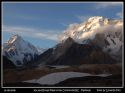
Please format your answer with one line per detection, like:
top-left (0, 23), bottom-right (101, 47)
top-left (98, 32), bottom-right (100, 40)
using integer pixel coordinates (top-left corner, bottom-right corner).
top-left (48, 43), bottom-right (116, 65)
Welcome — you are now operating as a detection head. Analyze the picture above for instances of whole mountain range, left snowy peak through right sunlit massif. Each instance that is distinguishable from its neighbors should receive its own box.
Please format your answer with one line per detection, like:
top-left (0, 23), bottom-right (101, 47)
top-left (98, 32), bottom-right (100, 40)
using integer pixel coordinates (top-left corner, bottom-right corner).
top-left (3, 16), bottom-right (123, 66)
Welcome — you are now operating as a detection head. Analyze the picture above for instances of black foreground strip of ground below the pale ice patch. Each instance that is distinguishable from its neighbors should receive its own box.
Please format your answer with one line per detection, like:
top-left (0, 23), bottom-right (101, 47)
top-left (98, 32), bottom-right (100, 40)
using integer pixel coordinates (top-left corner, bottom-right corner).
top-left (4, 75), bottom-right (122, 87)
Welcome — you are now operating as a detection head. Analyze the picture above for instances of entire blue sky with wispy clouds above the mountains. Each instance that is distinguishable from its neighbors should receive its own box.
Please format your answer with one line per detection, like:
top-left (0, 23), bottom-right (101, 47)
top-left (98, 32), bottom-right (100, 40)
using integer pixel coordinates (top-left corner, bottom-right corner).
top-left (2, 2), bottom-right (123, 48)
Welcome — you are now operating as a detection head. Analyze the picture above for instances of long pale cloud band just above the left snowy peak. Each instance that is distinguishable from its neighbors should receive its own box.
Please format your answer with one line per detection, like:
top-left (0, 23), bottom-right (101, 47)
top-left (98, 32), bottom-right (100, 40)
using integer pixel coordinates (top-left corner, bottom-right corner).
top-left (2, 26), bottom-right (60, 41)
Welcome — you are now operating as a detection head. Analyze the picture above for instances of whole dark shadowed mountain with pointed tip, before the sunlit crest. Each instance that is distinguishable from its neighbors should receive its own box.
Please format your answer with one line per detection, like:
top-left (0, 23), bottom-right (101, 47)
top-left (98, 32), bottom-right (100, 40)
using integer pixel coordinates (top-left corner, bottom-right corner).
top-left (36, 38), bottom-right (116, 65)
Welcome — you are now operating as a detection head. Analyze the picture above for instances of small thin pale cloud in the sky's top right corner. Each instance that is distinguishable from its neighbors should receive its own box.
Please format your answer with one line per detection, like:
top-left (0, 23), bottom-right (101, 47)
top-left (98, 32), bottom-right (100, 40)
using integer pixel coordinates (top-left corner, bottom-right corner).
top-left (95, 2), bottom-right (123, 9)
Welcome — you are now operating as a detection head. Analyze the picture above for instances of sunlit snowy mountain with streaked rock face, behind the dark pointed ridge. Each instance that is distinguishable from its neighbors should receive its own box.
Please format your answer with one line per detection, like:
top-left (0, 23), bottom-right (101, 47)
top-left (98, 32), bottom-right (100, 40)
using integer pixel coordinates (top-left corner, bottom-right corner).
top-left (60, 16), bottom-right (123, 60)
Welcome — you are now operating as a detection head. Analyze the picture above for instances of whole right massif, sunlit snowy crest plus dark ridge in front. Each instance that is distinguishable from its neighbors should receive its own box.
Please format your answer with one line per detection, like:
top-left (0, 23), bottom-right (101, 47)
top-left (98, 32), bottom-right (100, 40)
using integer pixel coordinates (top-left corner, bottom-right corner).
top-left (36, 16), bottom-right (123, 65)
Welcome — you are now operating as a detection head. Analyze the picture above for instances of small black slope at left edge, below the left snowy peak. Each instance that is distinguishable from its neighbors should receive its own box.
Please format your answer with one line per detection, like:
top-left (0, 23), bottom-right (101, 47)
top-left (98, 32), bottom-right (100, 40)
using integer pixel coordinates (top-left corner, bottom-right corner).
top-left (3, 56), bottom-right (15, 69)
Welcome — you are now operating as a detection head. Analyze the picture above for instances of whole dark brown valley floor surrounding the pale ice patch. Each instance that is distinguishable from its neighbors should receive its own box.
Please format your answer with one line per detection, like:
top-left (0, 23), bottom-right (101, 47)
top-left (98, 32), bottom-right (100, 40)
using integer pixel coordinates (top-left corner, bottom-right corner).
top-left (3, 64), bottom-right (122, 87)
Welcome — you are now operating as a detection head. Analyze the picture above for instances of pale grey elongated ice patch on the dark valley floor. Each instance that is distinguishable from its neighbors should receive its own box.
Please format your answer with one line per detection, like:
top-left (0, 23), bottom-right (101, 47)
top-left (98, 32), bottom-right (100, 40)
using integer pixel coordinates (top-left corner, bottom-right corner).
top-left (24, 72), bottom-right (111, 85)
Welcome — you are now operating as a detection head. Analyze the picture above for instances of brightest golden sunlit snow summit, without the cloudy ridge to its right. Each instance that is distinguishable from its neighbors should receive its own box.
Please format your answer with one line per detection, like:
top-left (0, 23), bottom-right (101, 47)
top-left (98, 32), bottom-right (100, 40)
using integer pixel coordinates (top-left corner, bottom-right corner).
top-left (60, 16), bottom-right (109, 42)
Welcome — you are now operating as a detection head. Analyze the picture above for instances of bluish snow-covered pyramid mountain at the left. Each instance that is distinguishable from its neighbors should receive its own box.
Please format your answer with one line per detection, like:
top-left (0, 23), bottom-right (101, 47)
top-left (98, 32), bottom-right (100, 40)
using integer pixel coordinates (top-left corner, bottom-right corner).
top-left (2, 35), bottom-right (38, 66)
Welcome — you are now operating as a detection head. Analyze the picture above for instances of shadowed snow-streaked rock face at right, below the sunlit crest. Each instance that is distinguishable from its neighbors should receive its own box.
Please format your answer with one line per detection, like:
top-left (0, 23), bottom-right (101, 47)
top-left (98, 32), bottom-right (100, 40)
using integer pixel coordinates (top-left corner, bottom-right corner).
top-left (89, 34), bottom-right (123, 61)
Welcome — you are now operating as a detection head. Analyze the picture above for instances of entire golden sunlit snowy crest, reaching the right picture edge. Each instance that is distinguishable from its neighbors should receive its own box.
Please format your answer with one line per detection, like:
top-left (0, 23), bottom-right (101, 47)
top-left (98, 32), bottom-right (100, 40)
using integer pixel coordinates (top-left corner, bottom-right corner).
top-left (60, 16), bottom-right (123, 42)
